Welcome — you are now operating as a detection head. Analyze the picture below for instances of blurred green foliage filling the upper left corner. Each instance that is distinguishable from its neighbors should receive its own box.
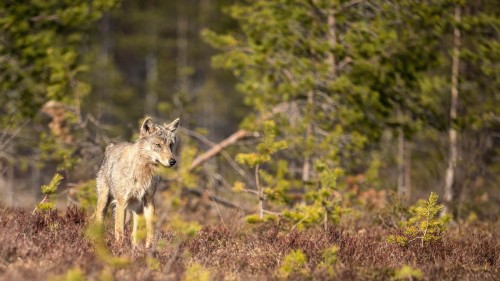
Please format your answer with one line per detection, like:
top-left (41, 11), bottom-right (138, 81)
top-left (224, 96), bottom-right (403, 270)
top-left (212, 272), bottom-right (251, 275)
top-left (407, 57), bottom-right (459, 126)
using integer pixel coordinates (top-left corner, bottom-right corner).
top-left (0, 0), bottom-right (117, 116)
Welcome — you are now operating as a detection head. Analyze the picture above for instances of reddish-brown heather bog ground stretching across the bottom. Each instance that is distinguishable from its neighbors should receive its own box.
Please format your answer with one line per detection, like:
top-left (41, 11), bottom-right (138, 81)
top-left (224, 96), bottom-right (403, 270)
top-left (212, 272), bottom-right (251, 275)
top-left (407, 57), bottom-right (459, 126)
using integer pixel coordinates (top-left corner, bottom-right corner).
top-left (0, 208), bottom-right (500, 280)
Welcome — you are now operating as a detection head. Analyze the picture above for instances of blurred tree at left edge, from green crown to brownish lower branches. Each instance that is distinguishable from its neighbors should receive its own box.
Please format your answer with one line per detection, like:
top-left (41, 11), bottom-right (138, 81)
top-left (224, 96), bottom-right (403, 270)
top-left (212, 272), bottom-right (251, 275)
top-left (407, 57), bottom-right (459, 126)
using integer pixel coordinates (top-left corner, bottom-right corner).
top-left (0, 0), bottom-right (117, 192)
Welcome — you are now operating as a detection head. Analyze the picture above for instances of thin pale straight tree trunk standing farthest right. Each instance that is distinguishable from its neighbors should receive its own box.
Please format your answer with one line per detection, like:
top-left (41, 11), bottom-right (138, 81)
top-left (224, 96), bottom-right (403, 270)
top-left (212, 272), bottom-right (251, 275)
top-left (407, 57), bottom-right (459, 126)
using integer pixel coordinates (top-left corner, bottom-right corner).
top-left (444, 5), bottom-right (461, 204)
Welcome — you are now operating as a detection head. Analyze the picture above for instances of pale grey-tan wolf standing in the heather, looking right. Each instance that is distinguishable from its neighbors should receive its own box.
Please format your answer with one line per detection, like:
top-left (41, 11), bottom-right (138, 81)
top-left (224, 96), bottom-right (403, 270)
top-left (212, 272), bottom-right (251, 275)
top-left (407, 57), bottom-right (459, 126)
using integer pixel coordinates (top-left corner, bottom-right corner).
top-left (95, 117), bottom-right (180, 247)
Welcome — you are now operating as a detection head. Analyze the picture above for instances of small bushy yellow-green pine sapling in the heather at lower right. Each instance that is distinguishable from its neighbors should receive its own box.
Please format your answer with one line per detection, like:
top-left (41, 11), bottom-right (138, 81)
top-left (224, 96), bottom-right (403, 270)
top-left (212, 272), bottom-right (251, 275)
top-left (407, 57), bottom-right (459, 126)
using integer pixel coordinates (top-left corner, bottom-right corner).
top-left (388, 192), bottom-right (451, 246)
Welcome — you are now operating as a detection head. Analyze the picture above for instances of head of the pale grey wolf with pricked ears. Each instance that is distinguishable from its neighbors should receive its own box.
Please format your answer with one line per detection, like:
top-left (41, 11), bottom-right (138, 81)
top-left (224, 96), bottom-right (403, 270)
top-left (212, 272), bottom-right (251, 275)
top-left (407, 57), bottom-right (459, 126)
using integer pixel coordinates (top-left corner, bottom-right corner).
top-left (138, 117), bottom-right (180, 167)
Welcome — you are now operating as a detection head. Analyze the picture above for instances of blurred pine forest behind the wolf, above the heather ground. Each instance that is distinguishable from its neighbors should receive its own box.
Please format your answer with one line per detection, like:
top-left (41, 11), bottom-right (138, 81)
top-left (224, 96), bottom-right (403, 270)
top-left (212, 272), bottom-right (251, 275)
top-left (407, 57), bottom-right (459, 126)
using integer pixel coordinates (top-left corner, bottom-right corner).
top-left (0, 0), bottom-right (500, 278)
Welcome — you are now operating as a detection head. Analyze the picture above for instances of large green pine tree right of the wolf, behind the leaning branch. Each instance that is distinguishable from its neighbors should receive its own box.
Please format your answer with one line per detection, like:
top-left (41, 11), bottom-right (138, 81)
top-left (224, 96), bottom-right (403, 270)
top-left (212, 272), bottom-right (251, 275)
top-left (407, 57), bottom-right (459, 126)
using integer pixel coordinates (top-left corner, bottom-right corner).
top-left (203, 1), bottom-right (376, 221)
